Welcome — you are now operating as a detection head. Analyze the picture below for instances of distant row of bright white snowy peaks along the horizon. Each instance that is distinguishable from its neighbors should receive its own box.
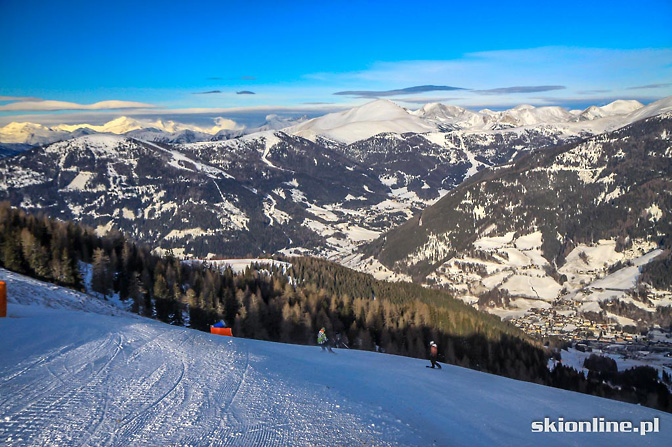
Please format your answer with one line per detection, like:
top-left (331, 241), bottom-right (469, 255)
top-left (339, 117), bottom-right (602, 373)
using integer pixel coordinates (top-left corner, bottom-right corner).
top-left (0, 98), bottom-right (669, 150)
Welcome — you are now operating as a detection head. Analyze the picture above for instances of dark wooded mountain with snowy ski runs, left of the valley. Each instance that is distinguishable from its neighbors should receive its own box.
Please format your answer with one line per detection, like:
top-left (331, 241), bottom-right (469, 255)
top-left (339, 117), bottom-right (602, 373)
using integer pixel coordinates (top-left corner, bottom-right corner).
top-left (0, 132), bottom-right (402, 257)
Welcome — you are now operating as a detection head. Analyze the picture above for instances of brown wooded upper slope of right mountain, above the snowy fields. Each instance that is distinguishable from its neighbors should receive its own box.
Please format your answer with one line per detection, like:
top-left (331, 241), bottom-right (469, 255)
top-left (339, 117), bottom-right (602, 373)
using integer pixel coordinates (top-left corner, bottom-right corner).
top-left (366, 113), bottom-right (672, 282)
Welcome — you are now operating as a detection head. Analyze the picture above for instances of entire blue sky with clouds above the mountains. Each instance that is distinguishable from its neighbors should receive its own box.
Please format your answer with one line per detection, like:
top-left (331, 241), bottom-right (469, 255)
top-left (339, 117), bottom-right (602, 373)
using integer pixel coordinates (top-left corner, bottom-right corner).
top-left (0, 0), bottom-right (672, 123)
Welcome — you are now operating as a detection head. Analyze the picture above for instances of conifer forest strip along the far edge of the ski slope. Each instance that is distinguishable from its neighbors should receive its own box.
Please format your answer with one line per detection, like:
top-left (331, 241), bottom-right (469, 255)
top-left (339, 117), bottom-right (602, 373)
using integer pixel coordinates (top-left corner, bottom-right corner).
top-left (0, 203), bottom-right (670, 409)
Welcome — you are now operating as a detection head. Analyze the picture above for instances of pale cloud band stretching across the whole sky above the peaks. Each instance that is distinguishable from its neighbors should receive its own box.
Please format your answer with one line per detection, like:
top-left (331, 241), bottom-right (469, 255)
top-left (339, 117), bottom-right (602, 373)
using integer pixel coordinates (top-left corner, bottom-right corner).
top-left (0, 47), bottom-right (672, 119)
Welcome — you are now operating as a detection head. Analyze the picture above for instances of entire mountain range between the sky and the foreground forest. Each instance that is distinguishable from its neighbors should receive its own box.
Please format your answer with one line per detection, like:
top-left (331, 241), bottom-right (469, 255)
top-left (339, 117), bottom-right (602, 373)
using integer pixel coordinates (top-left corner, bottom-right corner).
top-left (0, 98), bottom-right (672, 326)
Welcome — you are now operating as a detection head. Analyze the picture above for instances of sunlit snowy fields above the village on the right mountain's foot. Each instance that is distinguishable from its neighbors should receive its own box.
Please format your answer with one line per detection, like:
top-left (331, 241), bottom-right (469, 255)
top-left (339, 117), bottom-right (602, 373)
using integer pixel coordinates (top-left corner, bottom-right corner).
top-left (429, 231), bottom-right (667, 316)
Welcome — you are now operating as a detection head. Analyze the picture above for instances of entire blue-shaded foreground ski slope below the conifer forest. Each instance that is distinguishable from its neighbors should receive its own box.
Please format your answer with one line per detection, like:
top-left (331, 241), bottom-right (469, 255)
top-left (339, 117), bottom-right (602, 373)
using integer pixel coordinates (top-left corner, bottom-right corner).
top-left (0, 271), bottom-right (672, 446)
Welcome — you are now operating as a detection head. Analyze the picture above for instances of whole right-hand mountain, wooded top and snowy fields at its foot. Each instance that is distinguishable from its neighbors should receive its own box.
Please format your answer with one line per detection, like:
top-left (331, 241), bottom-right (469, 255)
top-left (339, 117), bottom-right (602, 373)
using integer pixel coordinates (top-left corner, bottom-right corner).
top-left (362, 110), bottom-right (672, 331)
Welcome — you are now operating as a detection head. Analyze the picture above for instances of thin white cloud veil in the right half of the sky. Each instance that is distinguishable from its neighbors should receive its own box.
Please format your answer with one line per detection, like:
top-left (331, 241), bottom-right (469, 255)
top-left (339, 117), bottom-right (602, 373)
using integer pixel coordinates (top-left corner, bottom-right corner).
top-left (306, 47), bottom-right (672, 106)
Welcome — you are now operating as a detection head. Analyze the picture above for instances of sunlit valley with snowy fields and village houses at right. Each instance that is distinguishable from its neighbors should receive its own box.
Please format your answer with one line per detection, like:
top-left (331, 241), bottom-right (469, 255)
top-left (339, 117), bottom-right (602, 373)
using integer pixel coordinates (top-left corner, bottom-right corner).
top-left (418, 232), bottom-right (672, 371)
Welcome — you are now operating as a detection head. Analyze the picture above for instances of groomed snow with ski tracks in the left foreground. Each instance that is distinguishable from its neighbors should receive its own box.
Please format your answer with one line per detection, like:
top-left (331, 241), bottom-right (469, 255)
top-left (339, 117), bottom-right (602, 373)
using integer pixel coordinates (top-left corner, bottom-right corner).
top-left (0, 306), bottom-right (402, 446)
